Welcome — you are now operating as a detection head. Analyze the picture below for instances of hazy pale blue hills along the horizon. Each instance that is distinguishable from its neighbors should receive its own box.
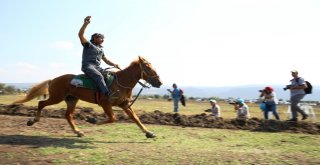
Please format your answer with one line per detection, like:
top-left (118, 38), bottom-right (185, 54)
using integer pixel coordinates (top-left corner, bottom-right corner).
top-left (6, 83), bottom-right (320, 101)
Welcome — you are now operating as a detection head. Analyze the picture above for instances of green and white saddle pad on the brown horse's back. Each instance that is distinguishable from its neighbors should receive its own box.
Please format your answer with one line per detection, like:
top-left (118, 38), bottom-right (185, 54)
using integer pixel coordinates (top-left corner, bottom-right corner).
top-left (70, 72), bottom-right (115, 91)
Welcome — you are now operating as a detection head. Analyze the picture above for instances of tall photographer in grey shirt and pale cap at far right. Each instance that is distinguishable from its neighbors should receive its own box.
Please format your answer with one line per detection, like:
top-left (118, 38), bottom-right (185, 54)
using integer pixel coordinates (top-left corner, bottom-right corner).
top-left (283, 70), bottom-right (308, 121)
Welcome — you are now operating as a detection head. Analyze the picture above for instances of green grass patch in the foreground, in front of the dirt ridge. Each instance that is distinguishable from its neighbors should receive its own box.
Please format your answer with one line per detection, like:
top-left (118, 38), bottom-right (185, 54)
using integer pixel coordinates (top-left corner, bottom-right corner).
top-left (6, 123), bottom-right (320, 165)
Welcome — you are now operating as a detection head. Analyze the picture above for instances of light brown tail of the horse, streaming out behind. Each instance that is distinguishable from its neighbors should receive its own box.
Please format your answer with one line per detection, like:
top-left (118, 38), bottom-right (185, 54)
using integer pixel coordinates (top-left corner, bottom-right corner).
top-left (12, 80), bottom-right (51, 104)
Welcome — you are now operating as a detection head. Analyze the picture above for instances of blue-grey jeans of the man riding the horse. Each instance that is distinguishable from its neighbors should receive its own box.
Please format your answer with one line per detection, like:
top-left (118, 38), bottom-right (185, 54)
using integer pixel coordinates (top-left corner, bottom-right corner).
top-left (81, 65), bottom-right (109, 94)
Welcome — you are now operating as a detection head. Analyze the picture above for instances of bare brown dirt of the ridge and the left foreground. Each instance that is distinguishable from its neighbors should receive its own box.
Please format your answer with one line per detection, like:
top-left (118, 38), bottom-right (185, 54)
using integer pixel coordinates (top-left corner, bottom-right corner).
top-left (0, 104), bottom-right (320, 165)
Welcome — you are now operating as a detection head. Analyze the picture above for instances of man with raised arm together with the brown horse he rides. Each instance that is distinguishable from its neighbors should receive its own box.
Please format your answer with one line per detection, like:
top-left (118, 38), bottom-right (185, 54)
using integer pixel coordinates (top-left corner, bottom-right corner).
top-left (12, 16), bottom-right (162, 138)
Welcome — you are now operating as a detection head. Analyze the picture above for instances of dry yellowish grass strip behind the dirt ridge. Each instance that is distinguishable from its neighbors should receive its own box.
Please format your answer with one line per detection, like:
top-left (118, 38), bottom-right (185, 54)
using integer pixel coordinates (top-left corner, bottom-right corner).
top-left (0, 95), bottom-right (320, 122)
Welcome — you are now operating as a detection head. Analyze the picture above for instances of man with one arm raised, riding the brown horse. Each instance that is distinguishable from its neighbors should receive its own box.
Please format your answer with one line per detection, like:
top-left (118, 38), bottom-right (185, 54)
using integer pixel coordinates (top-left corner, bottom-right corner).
top-left (78, 16), bottom-right (119, 96)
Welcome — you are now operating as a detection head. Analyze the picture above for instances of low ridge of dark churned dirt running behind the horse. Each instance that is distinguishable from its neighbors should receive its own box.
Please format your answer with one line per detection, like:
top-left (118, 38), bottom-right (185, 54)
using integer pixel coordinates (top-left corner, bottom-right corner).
top-left (0, 105), bottom-right (320, 134)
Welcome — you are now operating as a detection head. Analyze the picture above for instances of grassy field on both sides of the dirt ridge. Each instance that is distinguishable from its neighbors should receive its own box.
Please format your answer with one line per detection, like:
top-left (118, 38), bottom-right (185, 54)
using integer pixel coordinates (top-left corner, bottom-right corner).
top-left (0, 96), bottom-right (320, 164)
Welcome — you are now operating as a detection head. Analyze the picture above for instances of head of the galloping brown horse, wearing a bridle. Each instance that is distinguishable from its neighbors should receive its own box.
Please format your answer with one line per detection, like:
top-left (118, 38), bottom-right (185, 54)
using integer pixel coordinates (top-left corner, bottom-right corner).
top-left (139, 56), bottom-right (162, 88)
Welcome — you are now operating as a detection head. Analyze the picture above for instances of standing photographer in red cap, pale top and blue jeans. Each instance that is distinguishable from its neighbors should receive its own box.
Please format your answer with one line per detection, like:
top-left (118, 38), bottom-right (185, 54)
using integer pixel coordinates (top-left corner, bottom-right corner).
top-left (259, 86), bottom-right (280, 120)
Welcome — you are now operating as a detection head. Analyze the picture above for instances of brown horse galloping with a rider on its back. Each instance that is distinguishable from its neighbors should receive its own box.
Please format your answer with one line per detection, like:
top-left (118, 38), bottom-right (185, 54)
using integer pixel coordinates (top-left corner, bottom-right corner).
top-left (14, 56), bottom-right (162, 138)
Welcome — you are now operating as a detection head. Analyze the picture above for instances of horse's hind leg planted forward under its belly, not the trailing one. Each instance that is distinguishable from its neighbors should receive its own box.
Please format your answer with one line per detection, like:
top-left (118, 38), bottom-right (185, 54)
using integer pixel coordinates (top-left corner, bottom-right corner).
top-left (65, 96), bottom-right (84, 137)
